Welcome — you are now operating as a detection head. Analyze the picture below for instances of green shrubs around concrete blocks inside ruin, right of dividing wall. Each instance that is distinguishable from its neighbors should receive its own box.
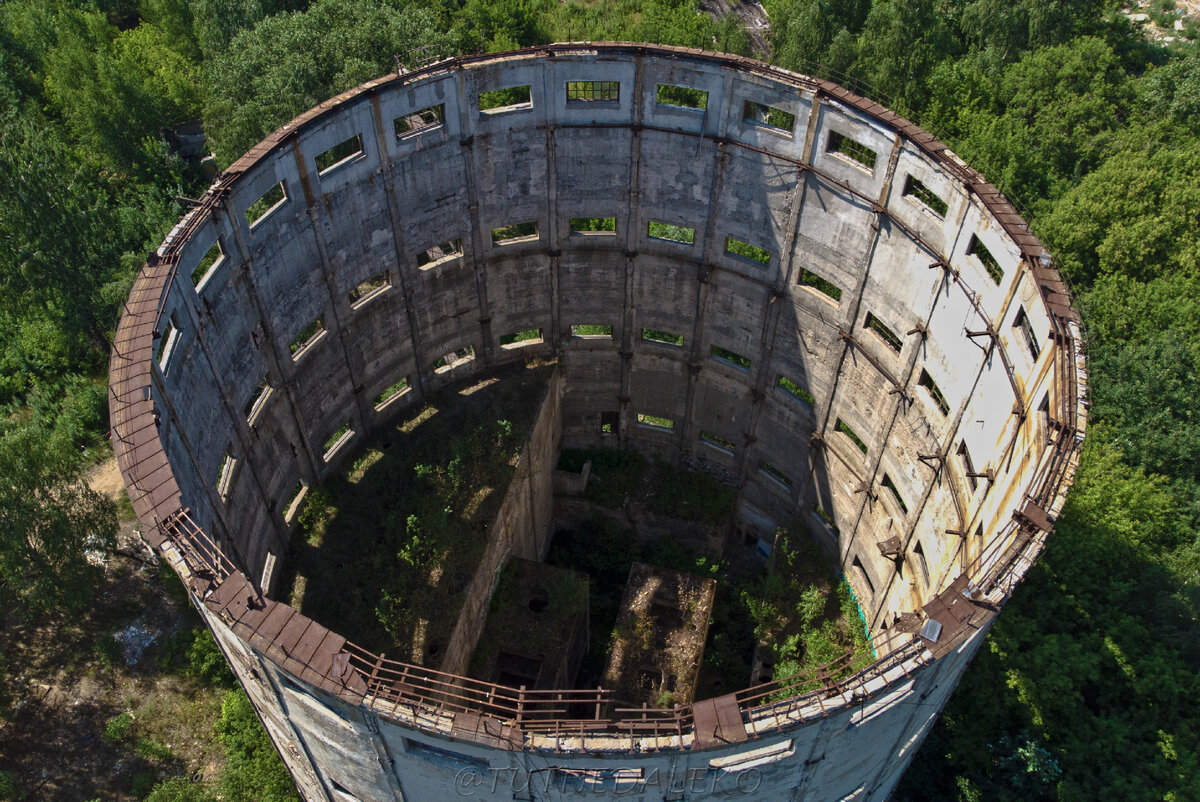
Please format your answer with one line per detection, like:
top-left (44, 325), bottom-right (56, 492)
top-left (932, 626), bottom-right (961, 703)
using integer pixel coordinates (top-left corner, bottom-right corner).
top-left (547, 449), bottom-right (874, 698)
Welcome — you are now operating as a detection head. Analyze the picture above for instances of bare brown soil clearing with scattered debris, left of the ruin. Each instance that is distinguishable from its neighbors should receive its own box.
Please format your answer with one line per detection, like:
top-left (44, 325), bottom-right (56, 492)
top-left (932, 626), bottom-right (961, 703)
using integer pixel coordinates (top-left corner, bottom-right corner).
top-left (0, 460), bottom-right (223, 801)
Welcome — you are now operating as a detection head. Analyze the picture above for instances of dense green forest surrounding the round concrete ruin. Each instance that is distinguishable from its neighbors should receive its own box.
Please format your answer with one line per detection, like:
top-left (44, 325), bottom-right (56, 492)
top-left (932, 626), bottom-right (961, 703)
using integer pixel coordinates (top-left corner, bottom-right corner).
top-left (0, 0), bottom-right (1200, 800)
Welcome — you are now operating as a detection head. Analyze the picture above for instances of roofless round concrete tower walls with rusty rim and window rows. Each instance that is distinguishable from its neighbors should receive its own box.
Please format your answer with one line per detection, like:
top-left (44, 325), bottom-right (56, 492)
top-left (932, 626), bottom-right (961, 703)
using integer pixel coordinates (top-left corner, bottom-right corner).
top-left (110, 44), bottom-right (1086, 801)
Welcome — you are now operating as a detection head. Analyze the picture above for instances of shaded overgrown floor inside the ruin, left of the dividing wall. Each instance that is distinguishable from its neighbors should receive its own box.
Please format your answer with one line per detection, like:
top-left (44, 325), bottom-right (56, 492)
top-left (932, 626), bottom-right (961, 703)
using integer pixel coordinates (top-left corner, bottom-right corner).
top-left (278, 365), bottom-right (553, 666)
